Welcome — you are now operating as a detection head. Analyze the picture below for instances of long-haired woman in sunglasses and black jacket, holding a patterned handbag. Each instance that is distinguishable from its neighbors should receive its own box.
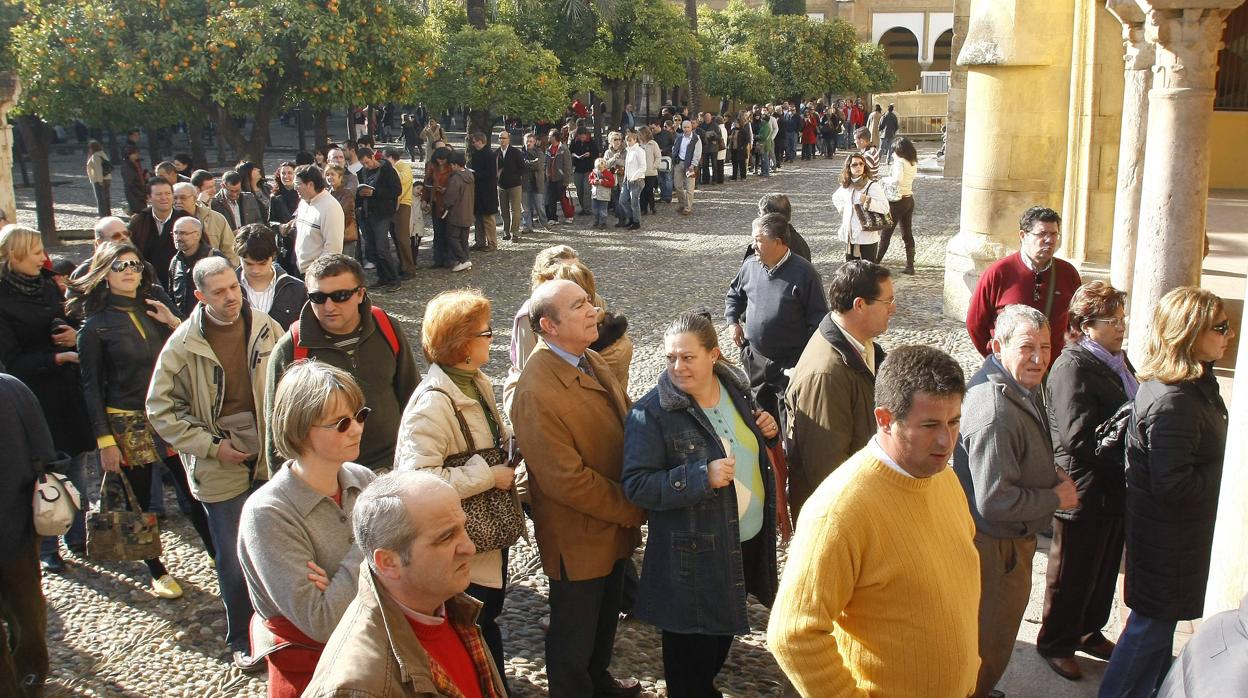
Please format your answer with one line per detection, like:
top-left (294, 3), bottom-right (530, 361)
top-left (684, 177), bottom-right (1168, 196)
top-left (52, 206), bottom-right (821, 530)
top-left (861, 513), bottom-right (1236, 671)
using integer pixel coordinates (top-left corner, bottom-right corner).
top-left (66, 242), bottom-right (216, 598)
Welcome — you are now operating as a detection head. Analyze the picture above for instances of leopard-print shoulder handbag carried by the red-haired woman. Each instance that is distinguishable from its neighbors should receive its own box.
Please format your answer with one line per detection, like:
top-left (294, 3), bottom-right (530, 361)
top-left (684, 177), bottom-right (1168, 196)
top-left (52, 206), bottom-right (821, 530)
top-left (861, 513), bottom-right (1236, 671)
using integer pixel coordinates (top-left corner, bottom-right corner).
top-left (428, 384), bottom-right (526, 553)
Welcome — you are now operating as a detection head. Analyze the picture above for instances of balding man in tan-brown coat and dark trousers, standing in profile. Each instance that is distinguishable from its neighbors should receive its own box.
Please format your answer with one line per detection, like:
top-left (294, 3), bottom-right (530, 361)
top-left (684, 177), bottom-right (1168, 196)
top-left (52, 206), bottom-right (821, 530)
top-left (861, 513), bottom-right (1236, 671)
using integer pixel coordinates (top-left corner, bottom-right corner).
top-left (512, 280), bottom-right (645, 698)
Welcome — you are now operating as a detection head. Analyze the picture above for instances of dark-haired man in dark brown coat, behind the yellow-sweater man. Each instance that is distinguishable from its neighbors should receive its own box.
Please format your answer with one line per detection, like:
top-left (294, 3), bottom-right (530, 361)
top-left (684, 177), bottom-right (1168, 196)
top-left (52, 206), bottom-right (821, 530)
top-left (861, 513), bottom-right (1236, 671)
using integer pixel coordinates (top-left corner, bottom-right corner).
top-left (785, 260), bottom-right (897, 522)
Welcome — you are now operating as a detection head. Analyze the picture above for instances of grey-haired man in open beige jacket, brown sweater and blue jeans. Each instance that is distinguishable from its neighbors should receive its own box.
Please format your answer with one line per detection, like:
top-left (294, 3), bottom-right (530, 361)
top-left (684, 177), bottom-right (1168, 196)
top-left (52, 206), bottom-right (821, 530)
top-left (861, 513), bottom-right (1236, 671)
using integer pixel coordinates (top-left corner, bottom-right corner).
top-left (147, 255), bottom-right (282, 671)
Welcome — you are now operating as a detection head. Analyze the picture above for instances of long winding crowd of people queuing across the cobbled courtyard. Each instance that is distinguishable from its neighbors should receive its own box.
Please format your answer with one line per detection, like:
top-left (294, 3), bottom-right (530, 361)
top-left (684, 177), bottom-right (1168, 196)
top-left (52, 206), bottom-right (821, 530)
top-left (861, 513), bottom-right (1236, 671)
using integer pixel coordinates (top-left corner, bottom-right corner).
top-left (0, 96), bottom-right (1234, 698)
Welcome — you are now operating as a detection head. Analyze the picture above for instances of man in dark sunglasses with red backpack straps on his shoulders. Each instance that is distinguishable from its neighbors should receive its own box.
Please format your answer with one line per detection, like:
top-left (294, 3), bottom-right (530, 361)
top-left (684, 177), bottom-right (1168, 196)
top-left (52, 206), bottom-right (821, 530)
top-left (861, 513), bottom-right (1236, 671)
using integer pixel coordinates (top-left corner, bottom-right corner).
top-left (265, 255), bottom-right (421, 474)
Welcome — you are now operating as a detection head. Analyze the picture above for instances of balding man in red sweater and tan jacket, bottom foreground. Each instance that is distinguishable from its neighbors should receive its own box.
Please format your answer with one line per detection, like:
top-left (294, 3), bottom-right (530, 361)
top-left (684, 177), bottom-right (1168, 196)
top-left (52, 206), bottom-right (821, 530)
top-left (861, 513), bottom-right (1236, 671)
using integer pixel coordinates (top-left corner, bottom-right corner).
top-left (303, 471), bottom-right (507, 698)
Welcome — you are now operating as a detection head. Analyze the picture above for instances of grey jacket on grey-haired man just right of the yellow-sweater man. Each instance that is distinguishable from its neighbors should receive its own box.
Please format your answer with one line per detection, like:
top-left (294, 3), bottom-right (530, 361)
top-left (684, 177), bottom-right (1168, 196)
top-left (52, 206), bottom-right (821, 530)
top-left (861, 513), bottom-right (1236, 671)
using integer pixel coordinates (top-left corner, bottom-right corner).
top-left (953, 356), bottom-right (1058, 538)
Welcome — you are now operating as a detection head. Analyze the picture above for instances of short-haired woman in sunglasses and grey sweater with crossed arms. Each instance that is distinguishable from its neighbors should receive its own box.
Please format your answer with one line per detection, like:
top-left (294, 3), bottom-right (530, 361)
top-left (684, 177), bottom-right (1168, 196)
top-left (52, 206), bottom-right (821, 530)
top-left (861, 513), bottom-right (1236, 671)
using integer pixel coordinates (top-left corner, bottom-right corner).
top-left (238, 361), bottom-right (376, 698)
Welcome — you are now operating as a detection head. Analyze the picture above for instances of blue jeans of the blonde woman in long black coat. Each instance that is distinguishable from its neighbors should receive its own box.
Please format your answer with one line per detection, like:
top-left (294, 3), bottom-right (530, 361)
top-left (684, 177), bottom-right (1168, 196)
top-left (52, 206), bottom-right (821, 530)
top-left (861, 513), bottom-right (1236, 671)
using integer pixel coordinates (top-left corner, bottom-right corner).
top-left (1097, 611), bottom-right (1177, 698)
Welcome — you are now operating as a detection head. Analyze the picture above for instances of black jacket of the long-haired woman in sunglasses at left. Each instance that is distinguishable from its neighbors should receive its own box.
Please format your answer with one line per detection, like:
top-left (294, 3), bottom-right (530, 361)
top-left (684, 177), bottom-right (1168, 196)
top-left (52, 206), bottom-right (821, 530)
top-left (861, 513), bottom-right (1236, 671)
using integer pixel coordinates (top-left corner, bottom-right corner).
top-left (79, 288), bottom-right (177, 444)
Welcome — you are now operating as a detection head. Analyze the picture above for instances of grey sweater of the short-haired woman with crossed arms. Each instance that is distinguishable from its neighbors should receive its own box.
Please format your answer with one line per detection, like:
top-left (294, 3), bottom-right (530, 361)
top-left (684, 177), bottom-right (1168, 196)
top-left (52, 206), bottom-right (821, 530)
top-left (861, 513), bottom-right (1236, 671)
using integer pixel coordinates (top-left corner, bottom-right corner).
top-left (238, 463), bottom-right (377, 642)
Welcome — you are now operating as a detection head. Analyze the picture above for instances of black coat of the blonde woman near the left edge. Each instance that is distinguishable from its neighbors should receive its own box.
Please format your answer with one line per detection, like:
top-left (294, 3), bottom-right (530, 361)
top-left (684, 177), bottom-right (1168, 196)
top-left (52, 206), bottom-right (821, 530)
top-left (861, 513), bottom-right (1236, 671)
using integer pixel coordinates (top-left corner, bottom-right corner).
top-left (0, 271), bottom-right (95, 457)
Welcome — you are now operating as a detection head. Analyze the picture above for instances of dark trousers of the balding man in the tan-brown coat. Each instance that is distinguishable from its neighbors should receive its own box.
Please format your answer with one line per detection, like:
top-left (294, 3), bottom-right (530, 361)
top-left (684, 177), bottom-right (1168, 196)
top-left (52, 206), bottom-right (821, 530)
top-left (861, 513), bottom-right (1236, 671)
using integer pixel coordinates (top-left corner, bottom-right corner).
top-left (545, 559), bottom-right (628, 698)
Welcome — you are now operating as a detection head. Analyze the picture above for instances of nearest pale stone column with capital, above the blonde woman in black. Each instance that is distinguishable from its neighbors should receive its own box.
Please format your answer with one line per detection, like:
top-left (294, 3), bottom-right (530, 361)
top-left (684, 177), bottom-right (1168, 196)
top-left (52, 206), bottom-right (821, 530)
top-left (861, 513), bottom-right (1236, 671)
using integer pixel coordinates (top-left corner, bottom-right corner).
top-left (1129, 0), bottom-right (1243, 357)
